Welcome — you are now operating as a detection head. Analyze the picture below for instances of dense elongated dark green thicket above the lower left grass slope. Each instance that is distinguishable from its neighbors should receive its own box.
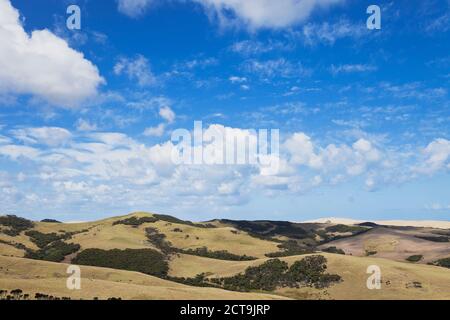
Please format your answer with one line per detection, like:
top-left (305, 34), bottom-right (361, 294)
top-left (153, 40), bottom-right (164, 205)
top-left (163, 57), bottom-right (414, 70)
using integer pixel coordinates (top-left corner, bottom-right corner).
top-left (72, 249), bottom-right (169, 277)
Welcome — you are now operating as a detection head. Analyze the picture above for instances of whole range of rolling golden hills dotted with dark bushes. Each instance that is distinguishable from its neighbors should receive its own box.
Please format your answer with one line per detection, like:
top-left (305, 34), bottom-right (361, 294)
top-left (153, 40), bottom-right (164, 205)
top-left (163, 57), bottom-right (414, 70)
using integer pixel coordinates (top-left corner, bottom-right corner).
top-left (0, 213), bottom-right (450, 299)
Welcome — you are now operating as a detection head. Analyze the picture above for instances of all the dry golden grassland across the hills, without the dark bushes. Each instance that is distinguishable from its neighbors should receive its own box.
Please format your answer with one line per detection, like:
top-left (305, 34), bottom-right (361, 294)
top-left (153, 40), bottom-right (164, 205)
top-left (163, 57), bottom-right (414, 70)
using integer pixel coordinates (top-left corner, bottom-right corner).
top-left (0, 213), bottom-right (450, 299)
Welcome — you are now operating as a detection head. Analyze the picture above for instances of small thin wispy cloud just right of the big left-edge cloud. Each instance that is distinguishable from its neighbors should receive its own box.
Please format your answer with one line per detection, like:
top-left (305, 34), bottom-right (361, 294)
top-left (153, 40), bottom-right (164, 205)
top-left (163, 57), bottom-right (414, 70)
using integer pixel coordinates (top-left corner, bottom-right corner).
top-left (114, 55), bottom-right (156, 87)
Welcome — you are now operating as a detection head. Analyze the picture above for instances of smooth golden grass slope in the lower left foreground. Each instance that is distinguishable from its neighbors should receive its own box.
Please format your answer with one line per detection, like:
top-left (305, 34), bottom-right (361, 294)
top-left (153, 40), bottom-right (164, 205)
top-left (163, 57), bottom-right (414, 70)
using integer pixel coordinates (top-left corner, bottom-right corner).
top-left (0, 256), bottom-right (283, 300)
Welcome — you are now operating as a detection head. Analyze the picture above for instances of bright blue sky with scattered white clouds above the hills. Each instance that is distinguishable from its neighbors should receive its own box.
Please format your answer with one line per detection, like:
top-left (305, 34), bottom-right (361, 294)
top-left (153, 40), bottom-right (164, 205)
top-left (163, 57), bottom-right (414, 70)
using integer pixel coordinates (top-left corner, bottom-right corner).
top-left (0, 0), bottom-right (450, 221)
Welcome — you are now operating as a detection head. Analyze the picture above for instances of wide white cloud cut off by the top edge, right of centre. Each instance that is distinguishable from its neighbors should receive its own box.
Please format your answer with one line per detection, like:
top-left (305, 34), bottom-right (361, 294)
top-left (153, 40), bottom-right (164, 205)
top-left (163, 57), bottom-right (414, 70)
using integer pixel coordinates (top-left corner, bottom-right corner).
top-left (193, 0), bottom-right (343, 30)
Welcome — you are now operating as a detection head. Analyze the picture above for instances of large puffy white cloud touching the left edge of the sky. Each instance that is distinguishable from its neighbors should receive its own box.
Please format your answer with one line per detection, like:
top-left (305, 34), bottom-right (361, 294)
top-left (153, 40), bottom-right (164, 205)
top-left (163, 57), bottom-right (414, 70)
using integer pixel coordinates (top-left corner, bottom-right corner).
top-left (0, 0), bottom-right (104, 107)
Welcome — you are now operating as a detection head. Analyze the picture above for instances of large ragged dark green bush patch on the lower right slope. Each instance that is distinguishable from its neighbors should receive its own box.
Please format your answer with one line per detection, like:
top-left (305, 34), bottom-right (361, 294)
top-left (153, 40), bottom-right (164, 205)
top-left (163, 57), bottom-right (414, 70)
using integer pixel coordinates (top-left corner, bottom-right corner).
top-left (211, 256), bottom-right (341, 291)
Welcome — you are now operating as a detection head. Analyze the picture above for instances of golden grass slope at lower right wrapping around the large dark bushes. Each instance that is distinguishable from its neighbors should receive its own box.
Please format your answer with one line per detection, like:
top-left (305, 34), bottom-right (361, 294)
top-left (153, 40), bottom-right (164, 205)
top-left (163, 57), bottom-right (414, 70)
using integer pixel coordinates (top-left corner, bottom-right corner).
top-left (170, 253), bottom-right (450, 300)
